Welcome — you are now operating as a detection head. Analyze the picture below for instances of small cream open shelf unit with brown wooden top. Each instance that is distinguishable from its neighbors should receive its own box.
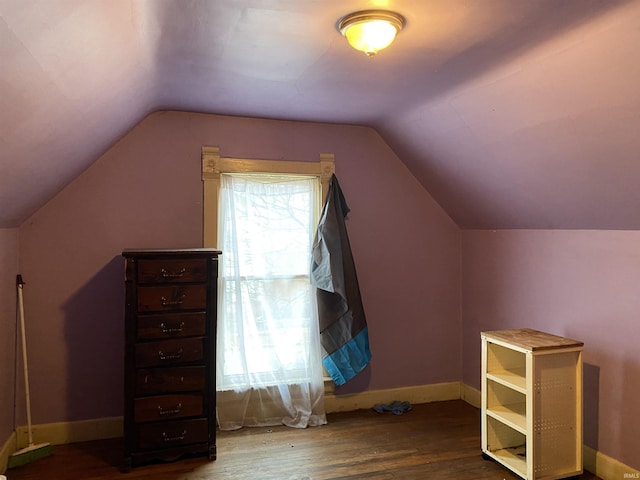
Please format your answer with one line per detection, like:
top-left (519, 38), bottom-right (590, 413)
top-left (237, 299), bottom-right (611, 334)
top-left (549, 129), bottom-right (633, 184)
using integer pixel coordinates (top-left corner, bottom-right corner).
top-left (481, 328), bottom-right (583, 480)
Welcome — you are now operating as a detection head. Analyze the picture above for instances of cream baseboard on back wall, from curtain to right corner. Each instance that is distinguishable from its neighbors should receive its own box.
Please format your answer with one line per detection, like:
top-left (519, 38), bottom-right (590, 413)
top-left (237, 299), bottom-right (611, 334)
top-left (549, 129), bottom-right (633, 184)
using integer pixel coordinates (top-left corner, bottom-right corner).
top-left (324, 382), bottom-right (460, 413)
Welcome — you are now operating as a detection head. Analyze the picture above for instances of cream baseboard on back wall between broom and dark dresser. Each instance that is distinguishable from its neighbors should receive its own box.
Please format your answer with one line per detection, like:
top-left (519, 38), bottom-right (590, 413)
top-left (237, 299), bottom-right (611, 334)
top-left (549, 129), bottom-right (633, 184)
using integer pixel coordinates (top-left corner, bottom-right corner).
top-left (16, 417), bottom-right (123, 449)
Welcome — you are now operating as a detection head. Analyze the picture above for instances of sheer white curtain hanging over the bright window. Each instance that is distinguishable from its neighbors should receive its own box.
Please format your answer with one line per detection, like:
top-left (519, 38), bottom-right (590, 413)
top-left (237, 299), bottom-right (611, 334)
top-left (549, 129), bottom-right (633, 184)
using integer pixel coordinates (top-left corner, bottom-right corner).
top-left (216, 174), bottom-right (326, 430)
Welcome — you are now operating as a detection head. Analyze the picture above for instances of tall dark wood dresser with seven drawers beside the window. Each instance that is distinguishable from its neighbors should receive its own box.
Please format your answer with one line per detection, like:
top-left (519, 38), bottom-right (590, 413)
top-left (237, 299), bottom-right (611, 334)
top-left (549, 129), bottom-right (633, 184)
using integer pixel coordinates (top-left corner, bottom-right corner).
top-left (122, 248), bottom-right (220, 470)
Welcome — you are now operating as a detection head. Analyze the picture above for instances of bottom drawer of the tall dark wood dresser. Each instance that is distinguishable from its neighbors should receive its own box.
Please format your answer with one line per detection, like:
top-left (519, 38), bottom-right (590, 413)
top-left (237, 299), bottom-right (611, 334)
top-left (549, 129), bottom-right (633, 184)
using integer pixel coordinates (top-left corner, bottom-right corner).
top-left (138, 418), bottom-right (209, 450)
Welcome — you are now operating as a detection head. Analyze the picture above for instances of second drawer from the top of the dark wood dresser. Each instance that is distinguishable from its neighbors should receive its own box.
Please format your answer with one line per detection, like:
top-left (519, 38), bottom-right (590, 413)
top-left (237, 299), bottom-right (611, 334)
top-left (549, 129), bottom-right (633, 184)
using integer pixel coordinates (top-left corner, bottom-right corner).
top-left (138, 285), bottom-right (207, 312)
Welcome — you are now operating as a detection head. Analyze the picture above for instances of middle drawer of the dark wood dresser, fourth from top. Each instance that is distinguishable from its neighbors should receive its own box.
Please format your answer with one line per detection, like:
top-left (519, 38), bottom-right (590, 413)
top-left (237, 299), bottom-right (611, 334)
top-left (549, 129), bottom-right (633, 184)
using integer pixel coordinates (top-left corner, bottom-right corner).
top-left (135, 337), bottom-right (204, 368)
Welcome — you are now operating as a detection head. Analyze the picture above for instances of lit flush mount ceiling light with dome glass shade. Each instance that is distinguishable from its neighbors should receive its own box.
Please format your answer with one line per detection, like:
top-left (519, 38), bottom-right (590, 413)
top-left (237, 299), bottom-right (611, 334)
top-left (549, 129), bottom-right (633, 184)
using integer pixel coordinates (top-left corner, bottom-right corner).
top-left (338, 10), bottom-right (404, 57)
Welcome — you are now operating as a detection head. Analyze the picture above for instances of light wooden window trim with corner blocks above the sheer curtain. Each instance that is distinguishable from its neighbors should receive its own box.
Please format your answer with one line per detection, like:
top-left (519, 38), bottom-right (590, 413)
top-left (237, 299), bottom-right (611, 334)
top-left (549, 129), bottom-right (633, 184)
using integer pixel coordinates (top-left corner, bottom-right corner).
top-left (202, 145), bottom-right (335, 247)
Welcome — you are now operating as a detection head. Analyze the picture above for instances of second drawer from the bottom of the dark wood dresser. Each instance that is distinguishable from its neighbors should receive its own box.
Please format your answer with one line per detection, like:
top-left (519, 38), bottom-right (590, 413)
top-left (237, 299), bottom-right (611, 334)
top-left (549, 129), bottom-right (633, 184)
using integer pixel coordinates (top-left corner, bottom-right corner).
top-left (133, 394), bottom-right (203, 423)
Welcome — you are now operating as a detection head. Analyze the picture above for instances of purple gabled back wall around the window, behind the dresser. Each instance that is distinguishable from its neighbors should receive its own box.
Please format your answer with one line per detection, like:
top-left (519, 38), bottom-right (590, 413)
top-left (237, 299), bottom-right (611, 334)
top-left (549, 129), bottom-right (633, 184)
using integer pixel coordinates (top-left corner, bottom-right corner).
top-left (17, 112), bottom-right (462, 424)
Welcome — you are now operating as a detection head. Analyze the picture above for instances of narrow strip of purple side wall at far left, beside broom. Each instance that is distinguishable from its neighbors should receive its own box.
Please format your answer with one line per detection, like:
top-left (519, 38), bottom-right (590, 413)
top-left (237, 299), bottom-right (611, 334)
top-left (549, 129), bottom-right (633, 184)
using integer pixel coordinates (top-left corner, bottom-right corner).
top-left (0, 228), bottom-right (18, 447)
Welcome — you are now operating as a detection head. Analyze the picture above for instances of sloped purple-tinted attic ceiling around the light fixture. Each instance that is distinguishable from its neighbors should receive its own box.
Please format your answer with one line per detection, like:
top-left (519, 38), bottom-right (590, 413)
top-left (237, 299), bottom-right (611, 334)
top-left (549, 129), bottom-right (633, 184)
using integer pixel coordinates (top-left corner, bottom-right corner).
top-left (0, 0), bottom-right (640, 229)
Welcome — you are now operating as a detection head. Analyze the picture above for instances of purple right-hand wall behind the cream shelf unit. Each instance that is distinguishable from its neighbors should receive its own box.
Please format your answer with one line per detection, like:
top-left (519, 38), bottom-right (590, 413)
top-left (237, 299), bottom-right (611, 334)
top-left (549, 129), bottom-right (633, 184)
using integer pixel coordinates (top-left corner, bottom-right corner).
top-left (462, 230), bottom-right (640, 468)
